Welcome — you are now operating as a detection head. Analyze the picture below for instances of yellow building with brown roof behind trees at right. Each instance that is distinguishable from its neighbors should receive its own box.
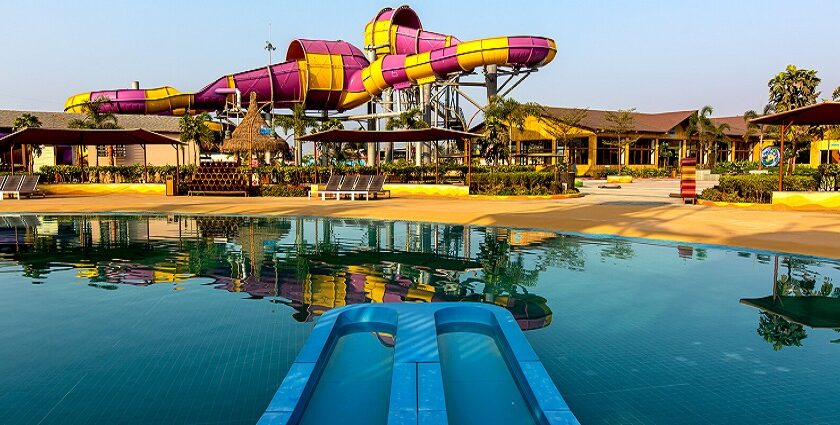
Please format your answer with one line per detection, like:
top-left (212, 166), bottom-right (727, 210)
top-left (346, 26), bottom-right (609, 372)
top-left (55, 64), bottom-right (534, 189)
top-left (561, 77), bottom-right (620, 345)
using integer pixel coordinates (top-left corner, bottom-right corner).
top-left (506, 107), bottom-right (840, 176)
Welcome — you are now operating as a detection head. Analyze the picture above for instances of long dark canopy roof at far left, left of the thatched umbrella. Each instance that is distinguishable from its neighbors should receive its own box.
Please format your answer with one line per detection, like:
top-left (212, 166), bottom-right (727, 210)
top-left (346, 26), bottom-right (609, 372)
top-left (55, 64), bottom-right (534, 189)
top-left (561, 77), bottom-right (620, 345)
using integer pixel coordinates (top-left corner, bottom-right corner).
top-left (0, 128), bottom-right (183, 146)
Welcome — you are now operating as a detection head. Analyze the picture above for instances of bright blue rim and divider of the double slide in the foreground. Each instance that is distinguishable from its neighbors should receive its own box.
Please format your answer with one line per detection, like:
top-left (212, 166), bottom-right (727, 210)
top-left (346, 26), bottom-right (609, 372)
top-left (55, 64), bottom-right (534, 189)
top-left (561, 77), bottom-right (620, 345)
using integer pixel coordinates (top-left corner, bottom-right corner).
top-left (261, 303), bottom-right (573, 425)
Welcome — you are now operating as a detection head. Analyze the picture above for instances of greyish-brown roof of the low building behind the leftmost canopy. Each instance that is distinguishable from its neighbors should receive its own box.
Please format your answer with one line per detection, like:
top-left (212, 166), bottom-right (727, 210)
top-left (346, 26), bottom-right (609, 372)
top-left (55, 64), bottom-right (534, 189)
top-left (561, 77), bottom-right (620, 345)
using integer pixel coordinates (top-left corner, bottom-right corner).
top-left (0, 109), bottom-right (181, 133)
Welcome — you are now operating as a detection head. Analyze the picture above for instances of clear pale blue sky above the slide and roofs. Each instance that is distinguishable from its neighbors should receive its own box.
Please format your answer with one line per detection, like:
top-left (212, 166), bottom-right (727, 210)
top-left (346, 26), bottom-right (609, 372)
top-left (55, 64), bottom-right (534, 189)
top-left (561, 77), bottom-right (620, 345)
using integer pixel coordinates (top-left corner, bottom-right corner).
top-left (0, 0), bottom-right (840, 115)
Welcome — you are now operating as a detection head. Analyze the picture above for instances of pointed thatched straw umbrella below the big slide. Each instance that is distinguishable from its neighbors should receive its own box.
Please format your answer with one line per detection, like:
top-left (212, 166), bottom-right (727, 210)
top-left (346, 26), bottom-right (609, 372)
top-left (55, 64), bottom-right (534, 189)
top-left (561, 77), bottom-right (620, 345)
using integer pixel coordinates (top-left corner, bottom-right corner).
top-left (220, 92), bottom-right (289, 159)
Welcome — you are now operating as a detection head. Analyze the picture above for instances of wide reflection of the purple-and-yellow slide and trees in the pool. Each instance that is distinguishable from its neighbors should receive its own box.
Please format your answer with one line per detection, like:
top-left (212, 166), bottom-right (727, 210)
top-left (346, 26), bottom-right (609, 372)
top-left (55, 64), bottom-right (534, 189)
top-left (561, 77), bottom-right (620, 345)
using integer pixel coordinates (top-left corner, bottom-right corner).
top-left (0, 216), bottom-right (568, 330)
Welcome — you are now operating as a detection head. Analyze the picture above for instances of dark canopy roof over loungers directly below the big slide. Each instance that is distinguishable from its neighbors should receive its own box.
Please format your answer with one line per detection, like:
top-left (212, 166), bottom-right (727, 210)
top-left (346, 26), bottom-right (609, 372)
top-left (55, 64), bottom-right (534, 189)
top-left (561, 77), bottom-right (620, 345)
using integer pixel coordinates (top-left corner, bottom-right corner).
top-left (298, 127), bottom-right (482, 143)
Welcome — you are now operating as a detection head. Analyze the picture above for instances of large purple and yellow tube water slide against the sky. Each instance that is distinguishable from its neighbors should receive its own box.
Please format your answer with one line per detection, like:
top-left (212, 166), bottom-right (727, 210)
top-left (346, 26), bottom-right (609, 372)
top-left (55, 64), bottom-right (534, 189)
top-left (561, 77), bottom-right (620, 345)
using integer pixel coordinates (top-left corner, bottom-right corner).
top-left (64, 6), bottom-right (557, 115)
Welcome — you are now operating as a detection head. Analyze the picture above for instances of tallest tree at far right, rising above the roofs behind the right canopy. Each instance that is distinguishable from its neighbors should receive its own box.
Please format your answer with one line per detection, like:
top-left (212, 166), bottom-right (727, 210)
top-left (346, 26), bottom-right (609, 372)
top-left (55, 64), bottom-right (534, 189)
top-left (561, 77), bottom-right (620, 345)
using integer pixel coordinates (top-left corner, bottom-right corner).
top-left (767, 65), bottom-right (821, 171)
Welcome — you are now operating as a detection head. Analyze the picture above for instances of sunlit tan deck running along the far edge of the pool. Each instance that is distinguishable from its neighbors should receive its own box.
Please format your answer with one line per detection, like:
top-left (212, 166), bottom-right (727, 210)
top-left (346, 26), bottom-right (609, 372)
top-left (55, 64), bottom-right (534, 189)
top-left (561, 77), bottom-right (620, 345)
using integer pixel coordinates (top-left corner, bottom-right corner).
top-left (0, 195), bottom-right (840, 258)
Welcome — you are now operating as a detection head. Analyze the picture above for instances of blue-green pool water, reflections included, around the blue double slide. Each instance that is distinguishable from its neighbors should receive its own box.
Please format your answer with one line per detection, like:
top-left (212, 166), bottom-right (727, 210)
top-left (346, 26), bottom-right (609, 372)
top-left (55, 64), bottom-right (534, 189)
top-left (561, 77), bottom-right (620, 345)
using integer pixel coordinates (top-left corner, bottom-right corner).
top-left (0, 216), bottom-right (840, 424)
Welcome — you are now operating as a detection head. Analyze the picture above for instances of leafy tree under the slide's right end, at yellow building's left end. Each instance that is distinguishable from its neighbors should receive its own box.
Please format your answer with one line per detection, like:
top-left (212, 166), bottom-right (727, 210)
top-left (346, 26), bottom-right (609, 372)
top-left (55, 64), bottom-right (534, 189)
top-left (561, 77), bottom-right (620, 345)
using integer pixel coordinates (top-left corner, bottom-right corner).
top-left (479, 96), bottom-right (544, 164)
